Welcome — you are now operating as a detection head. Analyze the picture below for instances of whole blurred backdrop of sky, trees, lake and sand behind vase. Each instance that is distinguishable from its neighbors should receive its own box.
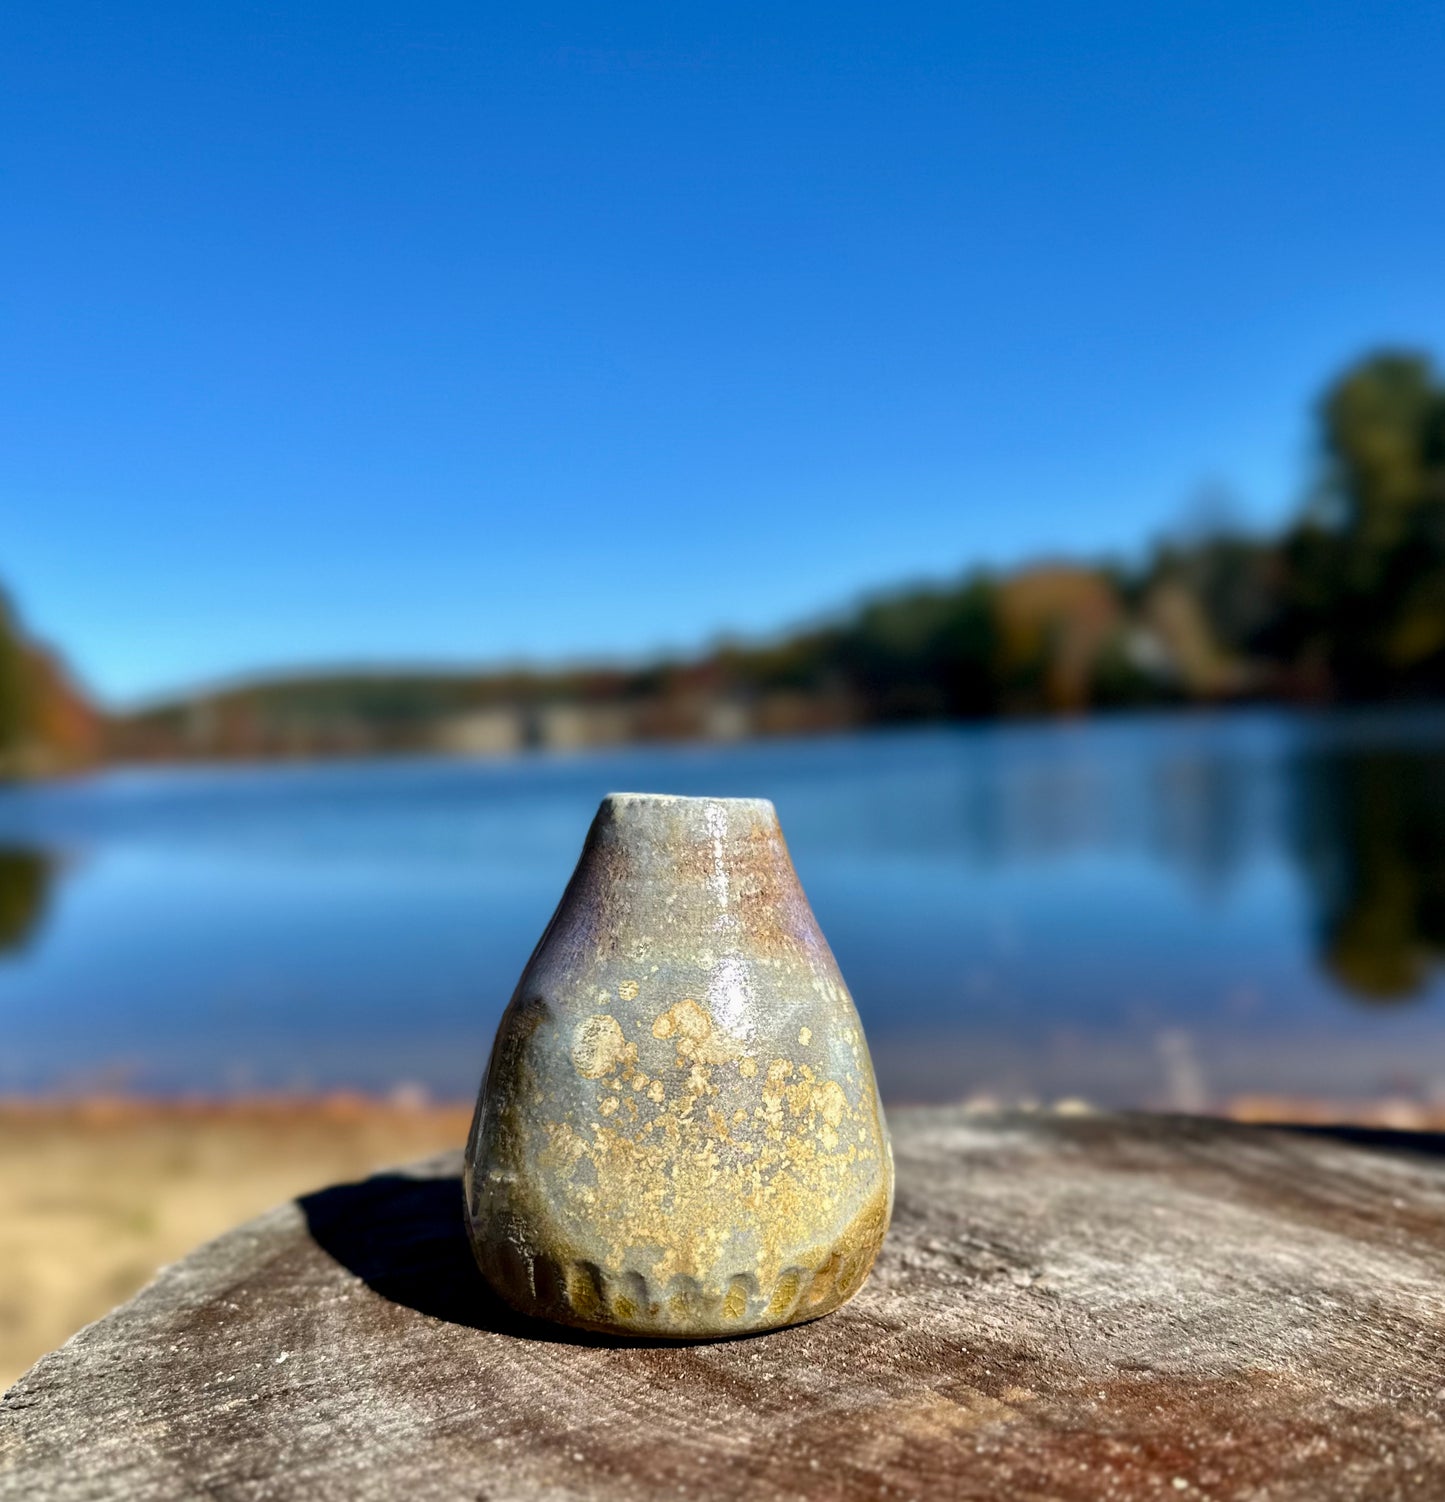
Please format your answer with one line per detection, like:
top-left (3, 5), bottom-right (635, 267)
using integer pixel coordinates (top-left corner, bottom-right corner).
top-left (0, 0), bottom-right (1445, 1386)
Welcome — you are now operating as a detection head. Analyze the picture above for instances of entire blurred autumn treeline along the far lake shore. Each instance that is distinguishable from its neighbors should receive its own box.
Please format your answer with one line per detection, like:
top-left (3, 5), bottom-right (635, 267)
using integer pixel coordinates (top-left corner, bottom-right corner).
top-left (0, 351), bottom-right (1445, 765)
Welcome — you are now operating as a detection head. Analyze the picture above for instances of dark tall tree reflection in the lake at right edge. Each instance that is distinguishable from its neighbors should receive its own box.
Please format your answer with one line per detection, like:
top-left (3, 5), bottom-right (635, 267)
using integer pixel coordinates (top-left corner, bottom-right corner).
top-left (1295, 749), bottom-right (1445, 1002)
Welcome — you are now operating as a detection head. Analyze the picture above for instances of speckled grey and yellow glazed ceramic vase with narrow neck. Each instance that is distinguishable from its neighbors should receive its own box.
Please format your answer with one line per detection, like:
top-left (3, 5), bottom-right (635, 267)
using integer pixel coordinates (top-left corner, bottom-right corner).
top-left (464, 793), bottom-right (894, 1338)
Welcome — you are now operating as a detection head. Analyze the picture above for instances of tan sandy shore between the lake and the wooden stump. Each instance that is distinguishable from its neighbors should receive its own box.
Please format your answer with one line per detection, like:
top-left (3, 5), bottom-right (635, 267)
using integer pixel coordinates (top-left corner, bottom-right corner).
top-left (0, 1096), bottom-right (1445, 1391)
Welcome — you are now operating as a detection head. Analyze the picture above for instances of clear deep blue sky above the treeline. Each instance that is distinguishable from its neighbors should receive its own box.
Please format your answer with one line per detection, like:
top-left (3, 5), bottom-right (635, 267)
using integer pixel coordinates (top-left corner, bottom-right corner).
top-left (0, 0), bottom-right (1445, 701)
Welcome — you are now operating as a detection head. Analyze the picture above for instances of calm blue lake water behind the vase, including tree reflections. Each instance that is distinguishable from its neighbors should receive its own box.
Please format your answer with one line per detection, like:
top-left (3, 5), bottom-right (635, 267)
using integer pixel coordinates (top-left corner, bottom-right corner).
top-left (0, 713), bottom-right (1445, 1107)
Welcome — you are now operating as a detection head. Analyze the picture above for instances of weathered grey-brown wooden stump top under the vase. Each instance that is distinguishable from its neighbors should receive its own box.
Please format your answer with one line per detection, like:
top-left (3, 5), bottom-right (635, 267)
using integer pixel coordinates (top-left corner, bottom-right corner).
top-left (0, 1110), bottom-right (1445, 1502)
